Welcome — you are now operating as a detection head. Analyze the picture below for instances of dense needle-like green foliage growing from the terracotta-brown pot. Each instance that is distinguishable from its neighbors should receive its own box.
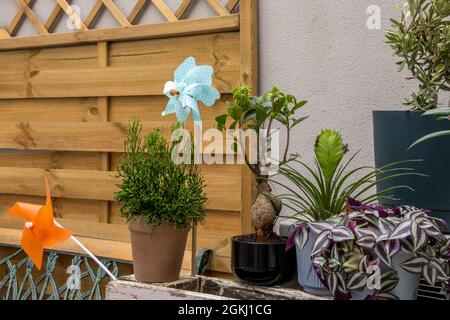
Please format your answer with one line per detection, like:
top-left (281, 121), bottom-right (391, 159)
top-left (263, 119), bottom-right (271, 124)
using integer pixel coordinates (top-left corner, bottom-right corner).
top-left (114, 119), bottom-right (207, 228)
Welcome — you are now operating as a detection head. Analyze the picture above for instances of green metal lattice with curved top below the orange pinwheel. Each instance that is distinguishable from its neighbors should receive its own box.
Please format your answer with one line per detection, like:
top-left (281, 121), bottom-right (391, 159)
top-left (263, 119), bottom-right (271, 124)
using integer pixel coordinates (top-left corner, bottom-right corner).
top-left (0, 245), bottom-right (130, 300)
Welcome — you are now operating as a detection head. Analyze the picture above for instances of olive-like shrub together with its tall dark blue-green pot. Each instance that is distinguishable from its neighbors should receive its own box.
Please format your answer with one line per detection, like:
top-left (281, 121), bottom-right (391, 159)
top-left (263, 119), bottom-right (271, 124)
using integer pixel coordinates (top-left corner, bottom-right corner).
top-left (373, 0), bottom-right (450, 229)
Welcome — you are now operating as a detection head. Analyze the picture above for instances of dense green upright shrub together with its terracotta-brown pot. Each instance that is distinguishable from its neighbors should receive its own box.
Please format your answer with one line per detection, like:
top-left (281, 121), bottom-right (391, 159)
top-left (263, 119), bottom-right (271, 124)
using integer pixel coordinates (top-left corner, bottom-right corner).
top-left (115, 119), bottom-right (207, 283)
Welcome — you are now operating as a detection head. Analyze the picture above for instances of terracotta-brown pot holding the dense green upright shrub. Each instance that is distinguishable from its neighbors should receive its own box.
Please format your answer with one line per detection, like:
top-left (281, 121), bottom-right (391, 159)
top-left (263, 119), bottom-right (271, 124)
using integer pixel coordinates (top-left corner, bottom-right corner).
top-left (128, 222), bottom-right (189, 283)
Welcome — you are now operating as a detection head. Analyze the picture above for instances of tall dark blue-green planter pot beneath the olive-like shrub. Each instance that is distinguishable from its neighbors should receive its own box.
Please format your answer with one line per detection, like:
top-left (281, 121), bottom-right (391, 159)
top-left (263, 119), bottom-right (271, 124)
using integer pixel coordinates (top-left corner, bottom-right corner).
top-left (373, 111), bottom-right (450, 232)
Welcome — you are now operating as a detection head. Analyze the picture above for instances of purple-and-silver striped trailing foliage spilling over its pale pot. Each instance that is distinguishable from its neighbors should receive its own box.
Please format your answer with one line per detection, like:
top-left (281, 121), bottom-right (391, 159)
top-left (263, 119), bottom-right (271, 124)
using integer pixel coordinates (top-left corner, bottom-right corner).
top-left (289, 199), bottom-right (450, 300)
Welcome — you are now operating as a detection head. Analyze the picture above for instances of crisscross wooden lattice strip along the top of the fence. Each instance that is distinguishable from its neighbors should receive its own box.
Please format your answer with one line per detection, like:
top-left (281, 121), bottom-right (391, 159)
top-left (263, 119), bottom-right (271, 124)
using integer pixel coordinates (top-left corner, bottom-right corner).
top-left (0, 0), bottom-right (243, 39)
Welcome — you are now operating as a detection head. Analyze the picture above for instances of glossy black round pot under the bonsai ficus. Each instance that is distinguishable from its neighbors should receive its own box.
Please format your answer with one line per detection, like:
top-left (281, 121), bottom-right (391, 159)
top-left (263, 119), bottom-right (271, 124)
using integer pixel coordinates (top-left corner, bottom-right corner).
top-left (231, 236), bottom-right (296, 286)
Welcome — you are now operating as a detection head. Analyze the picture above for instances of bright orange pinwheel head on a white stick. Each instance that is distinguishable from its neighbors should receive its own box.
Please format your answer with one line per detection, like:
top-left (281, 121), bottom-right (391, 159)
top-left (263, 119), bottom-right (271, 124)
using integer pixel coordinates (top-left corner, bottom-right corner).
top-left (8, 178), bottom-right (73, 270)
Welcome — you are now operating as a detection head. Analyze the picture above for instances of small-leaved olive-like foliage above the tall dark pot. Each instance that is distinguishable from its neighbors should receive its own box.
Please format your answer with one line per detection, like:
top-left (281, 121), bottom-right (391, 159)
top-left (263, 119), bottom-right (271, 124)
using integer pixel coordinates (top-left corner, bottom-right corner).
top-left (386, 0), bottom-right (450, 111)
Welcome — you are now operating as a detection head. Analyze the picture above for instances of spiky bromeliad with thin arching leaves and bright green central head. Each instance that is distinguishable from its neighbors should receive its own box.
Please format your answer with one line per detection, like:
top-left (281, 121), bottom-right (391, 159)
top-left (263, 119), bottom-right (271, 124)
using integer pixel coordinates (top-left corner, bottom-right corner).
top-left (274, 129), bottom-right (419, 222)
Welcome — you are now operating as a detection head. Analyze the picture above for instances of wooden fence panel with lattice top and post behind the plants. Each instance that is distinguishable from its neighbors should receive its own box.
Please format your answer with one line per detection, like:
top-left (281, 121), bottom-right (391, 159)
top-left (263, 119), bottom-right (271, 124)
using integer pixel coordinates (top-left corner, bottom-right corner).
top-left (0, 0), bottom-right (257, 273)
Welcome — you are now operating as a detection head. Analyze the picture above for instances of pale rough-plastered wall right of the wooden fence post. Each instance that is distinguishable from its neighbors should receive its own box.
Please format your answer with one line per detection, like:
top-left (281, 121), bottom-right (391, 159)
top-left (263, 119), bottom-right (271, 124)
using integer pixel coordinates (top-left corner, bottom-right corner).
top-left (260, 0), bottom-right (424, 169)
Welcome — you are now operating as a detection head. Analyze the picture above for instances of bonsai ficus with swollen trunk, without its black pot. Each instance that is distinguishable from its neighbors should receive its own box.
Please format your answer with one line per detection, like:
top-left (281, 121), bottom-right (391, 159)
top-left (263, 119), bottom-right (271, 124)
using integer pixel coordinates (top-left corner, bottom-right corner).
top-left (216, 85), bottom-right (307, 242)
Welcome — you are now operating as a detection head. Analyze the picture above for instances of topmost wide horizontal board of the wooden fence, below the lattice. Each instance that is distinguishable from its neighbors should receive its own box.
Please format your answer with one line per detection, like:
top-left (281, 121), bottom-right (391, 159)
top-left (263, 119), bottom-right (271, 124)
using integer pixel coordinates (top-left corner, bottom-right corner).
top-left (0, 33), bottom-right (240, 99)
